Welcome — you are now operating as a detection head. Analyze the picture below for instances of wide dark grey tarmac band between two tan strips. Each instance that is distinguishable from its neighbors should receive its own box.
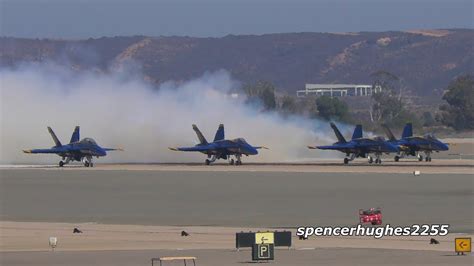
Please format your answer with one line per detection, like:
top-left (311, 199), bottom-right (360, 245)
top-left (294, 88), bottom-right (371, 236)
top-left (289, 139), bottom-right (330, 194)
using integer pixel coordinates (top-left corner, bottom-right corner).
top-left (0, 167), bottom-right (474, 233)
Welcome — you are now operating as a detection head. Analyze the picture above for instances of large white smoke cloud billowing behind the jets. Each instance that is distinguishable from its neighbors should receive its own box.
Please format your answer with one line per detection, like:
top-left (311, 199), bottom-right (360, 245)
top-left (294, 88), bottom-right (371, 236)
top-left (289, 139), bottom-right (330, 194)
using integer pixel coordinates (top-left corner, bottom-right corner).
top-left (0, 65), bottom-right (340, 164)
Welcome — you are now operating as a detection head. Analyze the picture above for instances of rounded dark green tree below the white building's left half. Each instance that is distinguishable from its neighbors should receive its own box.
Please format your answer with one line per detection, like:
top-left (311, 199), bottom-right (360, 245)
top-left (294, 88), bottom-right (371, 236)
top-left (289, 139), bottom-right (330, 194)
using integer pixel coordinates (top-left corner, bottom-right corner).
top-left (316, 95), bottom-right (350, 122)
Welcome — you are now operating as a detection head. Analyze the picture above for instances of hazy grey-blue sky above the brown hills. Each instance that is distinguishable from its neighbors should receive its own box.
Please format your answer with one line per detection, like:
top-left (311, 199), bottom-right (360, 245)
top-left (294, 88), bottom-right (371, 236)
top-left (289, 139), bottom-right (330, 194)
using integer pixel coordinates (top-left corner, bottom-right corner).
top-left (0, 0), bottom-right (474, 38)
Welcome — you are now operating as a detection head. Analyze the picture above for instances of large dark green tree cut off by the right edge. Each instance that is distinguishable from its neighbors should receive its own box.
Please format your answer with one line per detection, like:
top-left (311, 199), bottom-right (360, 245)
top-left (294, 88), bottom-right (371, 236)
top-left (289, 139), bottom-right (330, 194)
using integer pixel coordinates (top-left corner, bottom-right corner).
top-left (440, 75), bottom-right (474, 130)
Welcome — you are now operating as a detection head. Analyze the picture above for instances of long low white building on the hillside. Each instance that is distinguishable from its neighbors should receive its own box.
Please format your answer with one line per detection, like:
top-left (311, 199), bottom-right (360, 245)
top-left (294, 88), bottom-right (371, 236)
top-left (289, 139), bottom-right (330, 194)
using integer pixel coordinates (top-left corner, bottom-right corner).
top-left (296, 84), bottom-right (382, 97)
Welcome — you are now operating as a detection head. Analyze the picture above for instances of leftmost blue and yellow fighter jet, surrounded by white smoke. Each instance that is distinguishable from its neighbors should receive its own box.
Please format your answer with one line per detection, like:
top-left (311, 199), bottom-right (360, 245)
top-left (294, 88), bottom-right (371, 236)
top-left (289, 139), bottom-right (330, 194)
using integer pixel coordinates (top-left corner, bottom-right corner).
top-left (23, 126), bottom-right (122, 167)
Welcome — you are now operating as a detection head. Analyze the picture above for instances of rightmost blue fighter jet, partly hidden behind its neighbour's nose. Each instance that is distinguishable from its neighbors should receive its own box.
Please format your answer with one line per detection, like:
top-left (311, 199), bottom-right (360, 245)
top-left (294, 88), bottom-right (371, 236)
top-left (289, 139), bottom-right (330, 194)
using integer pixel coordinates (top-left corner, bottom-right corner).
top-left (382, 123), bottom-right (449, 162)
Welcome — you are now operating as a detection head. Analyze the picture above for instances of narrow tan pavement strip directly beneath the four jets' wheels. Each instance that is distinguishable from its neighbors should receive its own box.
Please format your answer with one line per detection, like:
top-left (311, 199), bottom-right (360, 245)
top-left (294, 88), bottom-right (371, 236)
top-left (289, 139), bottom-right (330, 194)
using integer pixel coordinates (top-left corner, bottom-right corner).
top-left (0, 159), bottom-right (474, 174)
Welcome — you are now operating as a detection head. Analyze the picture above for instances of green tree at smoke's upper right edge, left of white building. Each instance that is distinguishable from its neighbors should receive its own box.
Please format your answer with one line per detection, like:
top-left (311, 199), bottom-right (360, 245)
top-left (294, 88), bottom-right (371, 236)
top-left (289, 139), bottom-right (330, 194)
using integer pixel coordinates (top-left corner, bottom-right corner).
top-left (243, 81), bottom-right (276, 110)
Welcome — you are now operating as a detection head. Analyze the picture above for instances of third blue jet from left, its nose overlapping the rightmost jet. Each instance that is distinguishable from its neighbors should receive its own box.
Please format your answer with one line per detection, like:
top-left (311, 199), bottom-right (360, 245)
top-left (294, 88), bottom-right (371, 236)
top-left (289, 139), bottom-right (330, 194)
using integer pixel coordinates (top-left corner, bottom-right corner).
top-left (308, 123), bottom-right (399, 164)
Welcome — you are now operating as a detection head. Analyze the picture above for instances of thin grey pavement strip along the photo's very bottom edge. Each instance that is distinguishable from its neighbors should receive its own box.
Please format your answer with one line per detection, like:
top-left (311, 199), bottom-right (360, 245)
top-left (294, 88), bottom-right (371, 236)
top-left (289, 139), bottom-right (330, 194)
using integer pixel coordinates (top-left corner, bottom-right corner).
top-left (0, 248), bottom-right (473, 266)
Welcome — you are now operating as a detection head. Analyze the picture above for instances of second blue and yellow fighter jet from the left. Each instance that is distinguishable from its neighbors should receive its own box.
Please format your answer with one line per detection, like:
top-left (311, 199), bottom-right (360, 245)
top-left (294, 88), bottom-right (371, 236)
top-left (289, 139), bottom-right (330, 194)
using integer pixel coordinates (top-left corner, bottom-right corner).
top-left (169, 124), bottom-right (267, 165)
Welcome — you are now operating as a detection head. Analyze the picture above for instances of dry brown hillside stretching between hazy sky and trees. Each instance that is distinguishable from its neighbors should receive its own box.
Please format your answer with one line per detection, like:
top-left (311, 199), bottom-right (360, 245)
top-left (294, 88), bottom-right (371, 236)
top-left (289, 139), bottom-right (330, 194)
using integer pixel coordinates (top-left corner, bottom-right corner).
top-left (0, 30), bottom-right (474, 99)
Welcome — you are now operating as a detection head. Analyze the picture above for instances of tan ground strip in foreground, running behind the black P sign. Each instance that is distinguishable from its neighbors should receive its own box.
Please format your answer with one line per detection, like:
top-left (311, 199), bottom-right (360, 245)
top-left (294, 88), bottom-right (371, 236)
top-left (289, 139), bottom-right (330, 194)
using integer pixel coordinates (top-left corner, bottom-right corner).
top-left (0, 221), bottom-right (472, 252)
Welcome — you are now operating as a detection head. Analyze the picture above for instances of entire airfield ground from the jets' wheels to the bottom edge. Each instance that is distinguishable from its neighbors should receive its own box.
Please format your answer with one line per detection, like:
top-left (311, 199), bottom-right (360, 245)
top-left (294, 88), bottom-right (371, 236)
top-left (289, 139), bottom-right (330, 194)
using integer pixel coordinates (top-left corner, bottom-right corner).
top-left (0, 163), bottom-right (474, 266)
